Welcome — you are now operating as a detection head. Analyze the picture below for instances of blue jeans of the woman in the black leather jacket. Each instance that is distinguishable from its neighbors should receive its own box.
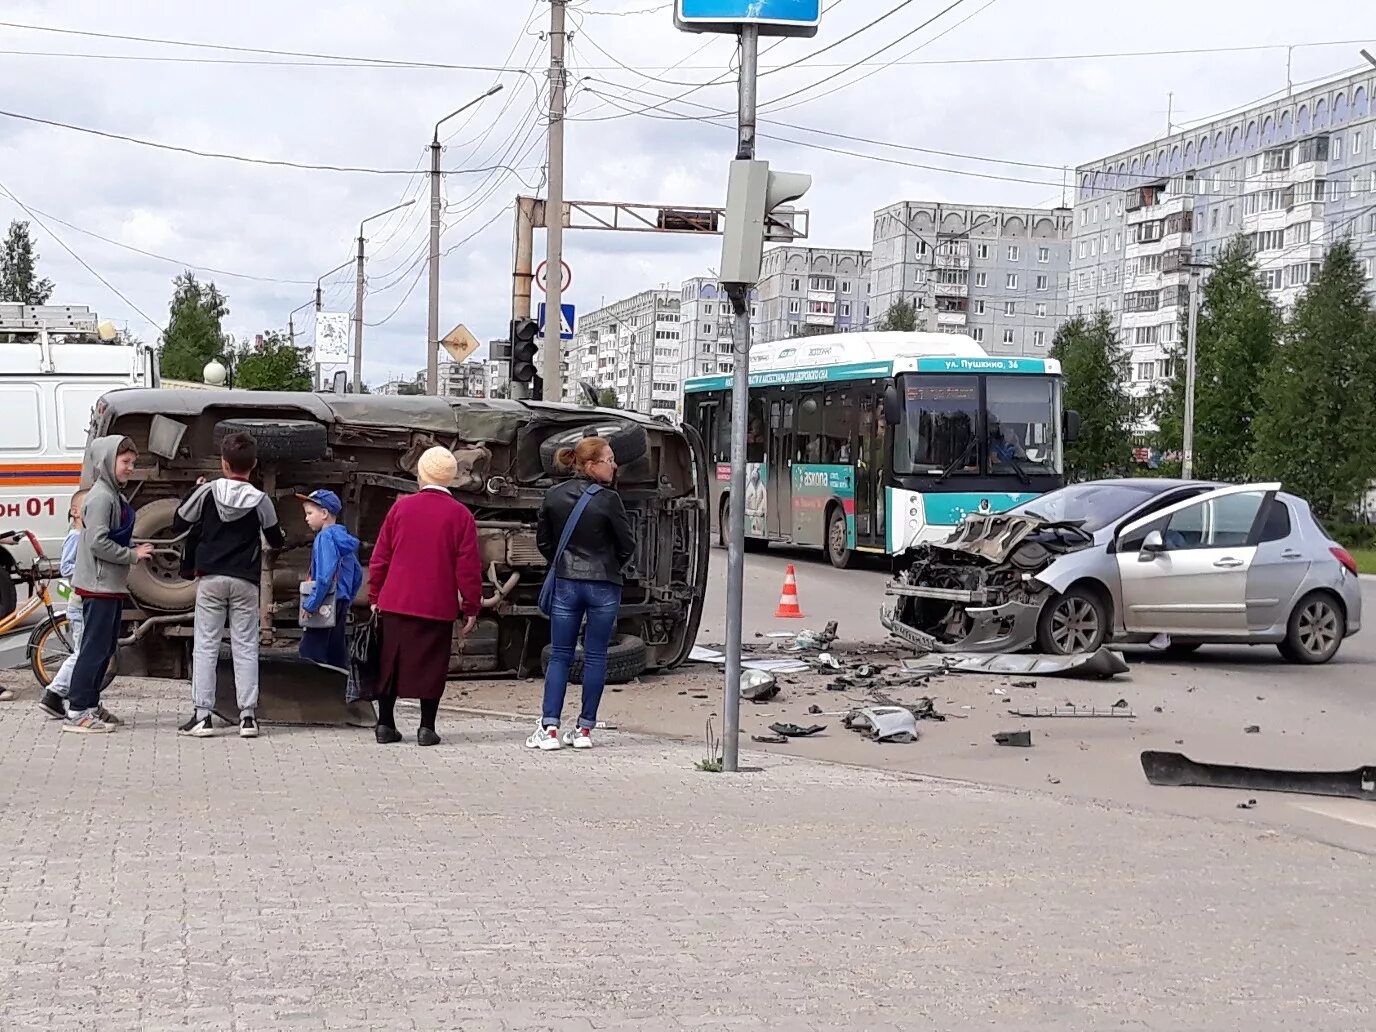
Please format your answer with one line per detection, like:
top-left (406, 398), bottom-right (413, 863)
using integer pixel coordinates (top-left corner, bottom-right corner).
top-left (539, 577), bottom-right (621, 728)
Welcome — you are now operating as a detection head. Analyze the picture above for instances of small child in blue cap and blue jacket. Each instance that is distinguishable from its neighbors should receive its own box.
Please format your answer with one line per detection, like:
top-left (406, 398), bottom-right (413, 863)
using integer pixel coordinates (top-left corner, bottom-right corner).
top-left (297, 490), bottom-right (363, 674)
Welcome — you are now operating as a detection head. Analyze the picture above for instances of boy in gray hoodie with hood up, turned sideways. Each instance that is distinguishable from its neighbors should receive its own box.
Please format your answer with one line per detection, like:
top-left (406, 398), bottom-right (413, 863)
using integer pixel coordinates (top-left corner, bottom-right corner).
top-left (62, 436), bottom-right (153, 735)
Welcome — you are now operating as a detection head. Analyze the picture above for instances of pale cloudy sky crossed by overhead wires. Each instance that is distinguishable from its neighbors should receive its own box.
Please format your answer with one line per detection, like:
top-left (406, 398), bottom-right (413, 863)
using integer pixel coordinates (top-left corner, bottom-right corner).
top-left (0, 0), bottom-right (1376, 383)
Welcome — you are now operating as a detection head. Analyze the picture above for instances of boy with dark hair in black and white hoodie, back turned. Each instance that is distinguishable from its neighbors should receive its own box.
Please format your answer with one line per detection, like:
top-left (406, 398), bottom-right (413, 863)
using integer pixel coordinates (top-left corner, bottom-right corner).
top-left (172, 433), bottom-right (286, 738)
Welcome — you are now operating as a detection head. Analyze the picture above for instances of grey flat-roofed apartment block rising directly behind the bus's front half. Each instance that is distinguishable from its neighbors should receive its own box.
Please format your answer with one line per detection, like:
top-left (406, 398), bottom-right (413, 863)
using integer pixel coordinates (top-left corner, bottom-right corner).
top-left (868, 201), bottom-right (1073, 355)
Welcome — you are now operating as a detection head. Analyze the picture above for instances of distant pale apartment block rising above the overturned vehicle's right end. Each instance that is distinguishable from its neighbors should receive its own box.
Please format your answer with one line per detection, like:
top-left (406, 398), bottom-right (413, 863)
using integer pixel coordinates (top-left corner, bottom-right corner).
top-left (564, 290), bottom-right (680, 414)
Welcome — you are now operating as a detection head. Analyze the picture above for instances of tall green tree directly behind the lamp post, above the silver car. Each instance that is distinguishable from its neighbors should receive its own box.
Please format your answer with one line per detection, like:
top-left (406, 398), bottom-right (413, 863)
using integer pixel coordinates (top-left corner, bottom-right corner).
top-left (1156, 237), bottom-right (1282, 482)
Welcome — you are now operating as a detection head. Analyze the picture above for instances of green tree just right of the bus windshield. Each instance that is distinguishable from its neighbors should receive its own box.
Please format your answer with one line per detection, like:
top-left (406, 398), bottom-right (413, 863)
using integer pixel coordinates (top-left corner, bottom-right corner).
top-left (1051, 311), bottom-right (1138, 480)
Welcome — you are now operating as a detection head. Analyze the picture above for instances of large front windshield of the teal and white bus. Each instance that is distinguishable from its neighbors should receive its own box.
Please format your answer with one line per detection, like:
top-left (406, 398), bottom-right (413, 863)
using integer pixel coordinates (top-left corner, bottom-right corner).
top-left (893, 373), bottom-right (1061, 479)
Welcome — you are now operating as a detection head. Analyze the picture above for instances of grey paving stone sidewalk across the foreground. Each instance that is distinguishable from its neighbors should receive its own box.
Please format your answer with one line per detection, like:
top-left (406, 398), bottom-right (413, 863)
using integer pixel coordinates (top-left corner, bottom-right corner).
top-left (0, 681), bottom-right (1376, 1032)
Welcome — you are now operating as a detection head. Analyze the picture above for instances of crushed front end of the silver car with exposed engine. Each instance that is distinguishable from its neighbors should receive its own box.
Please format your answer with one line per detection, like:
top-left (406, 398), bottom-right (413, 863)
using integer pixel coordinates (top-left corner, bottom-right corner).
top-left (879, 513), bottom-right (1094, 652)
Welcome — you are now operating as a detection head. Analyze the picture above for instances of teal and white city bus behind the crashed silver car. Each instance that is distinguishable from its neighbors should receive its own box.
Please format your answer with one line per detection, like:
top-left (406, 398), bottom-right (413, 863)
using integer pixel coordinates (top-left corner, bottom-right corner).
top-left (684, 333), bottom-right (1079, 568)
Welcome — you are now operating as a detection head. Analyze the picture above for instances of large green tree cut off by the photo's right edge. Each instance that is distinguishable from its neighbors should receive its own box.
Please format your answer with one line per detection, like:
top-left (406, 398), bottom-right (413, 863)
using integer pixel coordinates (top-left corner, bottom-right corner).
top-left (1251, 241), bottom-right (1376, 519)
